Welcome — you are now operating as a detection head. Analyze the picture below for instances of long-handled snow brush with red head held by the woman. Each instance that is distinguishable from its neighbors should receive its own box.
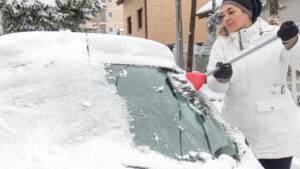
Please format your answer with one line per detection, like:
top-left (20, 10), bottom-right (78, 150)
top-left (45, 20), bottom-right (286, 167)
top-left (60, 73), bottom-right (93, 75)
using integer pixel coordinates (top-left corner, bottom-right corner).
top-left (185, 23), bottom-right (300, 91)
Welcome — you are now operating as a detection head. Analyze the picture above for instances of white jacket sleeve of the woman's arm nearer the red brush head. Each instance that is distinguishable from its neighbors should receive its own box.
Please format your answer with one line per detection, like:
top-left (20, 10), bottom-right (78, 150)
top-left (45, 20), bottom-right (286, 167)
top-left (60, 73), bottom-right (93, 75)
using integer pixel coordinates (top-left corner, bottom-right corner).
top-left (207, 37), bottom-right (229, 93)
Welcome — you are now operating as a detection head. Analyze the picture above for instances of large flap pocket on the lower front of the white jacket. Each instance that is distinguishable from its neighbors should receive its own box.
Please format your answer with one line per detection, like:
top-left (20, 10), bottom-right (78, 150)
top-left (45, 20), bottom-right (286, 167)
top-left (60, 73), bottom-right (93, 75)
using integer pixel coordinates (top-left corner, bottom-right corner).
top-left (256, 100), bottom-right (289, 146)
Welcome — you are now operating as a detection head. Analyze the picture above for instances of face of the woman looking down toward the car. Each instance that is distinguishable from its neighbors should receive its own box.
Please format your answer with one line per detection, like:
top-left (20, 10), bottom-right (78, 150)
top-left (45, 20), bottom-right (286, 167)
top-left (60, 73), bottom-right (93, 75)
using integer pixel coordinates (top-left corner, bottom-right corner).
top-left (222, 4), bottom-right (252, 32)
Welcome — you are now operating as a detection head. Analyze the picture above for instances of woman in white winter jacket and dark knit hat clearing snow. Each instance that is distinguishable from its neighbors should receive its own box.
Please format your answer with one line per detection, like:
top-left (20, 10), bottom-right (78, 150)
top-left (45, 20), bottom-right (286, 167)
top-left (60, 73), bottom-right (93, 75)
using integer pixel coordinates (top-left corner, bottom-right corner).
top-left (207, 0), bottom-right (300, 169)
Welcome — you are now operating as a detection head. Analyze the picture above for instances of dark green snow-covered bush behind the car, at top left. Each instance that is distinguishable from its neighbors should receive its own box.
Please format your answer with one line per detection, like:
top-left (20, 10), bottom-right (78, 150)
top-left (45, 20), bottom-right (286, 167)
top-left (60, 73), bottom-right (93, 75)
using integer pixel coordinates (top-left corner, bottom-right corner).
top-left (0, 0), bottom-right (105, 33)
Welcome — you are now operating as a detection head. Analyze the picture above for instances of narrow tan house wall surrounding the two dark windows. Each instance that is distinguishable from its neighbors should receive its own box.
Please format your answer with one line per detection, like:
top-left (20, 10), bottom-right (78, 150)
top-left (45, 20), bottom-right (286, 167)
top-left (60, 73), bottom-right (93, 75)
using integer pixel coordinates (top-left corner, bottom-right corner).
top-left (123, 0), bottom-right (145, 38)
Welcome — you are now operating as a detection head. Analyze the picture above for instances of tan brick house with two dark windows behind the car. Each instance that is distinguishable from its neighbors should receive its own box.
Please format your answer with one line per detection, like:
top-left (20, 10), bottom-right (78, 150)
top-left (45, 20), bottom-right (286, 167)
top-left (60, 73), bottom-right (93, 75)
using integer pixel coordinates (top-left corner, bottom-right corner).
top-left (117, 0), bottom-right (208, 45)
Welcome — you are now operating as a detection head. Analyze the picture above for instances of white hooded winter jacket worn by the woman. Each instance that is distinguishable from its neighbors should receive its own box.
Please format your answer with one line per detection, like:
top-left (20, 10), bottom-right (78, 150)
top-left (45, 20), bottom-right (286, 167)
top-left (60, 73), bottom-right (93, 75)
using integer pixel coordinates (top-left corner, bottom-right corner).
top-left (207, 18), bottom-right (300, 159)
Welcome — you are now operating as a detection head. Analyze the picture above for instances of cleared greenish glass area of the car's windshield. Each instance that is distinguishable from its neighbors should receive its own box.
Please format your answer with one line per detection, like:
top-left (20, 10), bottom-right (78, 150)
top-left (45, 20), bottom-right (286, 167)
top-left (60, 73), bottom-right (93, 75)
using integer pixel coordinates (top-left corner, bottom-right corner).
top-left (107, 65), bottom-right (236, 160)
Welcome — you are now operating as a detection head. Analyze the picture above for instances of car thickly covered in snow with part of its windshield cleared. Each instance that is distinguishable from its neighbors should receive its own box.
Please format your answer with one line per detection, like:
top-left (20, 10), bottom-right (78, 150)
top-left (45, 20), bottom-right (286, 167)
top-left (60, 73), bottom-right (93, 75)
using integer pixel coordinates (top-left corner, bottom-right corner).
top-left (0, 32), bottom-right (261, 169)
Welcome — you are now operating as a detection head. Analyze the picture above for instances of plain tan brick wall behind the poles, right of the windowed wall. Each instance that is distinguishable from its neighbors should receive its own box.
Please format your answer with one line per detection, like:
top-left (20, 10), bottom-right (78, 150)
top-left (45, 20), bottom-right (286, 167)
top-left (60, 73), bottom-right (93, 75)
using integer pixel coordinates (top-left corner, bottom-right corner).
top-left (147, 0), bottom-right (208, 44)
